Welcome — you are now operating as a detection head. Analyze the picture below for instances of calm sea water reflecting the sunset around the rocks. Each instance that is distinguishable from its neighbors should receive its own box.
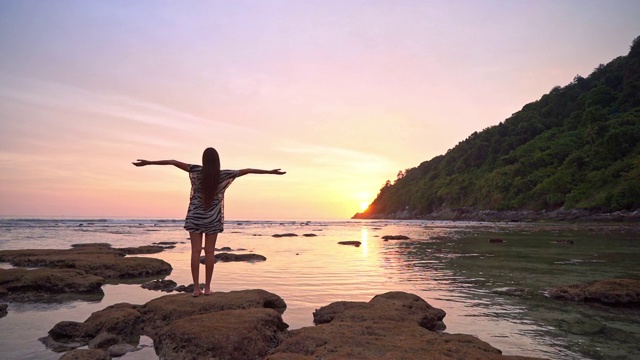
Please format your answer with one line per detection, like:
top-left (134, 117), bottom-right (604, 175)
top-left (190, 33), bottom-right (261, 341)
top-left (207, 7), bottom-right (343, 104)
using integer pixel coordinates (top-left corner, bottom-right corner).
top-left (0, 219), bottom-right (640, 360)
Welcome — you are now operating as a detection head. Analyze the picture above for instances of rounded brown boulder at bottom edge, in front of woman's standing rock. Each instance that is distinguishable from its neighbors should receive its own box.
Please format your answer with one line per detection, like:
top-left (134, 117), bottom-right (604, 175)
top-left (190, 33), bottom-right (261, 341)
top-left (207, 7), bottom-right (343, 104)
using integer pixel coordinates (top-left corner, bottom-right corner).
top-left (154, 308), bottom-right (288, 360)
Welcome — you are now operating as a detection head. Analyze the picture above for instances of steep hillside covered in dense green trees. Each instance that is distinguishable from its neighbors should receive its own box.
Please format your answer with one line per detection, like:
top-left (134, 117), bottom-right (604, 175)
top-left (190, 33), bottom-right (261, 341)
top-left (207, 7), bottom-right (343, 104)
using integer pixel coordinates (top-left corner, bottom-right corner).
top-left (361, 37), bottom-right (640, 217)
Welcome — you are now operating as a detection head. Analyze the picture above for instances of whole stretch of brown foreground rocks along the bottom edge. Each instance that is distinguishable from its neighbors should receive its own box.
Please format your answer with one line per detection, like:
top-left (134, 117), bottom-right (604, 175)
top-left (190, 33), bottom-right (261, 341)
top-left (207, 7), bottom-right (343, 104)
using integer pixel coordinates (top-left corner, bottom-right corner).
top-left (46, 289), bottom-right (535, 360)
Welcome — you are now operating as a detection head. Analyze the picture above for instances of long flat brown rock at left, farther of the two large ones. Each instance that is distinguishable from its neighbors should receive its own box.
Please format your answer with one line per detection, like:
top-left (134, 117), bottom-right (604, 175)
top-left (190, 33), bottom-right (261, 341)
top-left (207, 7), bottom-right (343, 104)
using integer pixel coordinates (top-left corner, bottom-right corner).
top-left (0, 244), bottom-right (172, 279)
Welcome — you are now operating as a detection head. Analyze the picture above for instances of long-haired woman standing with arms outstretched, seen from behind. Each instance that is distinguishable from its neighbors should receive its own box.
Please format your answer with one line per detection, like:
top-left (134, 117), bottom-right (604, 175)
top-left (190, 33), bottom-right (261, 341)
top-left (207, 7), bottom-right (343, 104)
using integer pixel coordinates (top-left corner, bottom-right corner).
top-left (133, 148), bottom-right (285, 297)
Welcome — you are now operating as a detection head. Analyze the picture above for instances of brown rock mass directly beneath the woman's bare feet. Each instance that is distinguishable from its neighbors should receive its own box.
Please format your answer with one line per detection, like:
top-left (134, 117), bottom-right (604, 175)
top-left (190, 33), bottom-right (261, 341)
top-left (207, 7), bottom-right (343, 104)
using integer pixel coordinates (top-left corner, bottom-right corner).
top-left (47, 290), bottom-right (288, 359)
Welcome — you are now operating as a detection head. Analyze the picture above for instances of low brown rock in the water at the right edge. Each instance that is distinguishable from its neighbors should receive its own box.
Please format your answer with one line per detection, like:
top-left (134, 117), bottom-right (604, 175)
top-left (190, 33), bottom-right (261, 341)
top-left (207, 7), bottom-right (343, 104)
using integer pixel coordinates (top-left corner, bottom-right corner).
top-left (547, 279), bottom-right (640, 307)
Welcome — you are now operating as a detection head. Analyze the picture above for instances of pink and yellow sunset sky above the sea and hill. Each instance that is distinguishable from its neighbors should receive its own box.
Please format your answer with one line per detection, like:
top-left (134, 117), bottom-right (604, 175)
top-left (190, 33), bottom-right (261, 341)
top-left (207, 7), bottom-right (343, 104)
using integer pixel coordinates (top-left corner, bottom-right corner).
top-left (0, 0), bottom-right (640, 220)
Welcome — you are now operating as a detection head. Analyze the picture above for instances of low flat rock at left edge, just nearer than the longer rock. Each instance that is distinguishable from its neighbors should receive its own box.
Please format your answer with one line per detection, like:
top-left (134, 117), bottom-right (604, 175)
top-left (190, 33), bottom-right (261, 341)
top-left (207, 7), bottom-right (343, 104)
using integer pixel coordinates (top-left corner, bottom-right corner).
top-left (0, 268), bottom-right (105, 301)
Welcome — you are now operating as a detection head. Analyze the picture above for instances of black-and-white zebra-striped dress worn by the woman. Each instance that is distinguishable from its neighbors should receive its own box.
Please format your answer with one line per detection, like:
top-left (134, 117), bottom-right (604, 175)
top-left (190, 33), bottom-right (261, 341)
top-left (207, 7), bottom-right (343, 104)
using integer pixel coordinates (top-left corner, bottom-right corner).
top-left (184, 165), bottom-right (238, 234)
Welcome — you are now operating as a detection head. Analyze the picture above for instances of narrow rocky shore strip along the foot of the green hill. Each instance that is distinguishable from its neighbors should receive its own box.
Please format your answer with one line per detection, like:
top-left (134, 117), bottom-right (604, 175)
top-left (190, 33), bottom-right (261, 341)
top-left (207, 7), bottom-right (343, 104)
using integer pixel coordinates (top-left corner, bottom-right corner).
top-left (352, 208), bottom-right (640, 224)
